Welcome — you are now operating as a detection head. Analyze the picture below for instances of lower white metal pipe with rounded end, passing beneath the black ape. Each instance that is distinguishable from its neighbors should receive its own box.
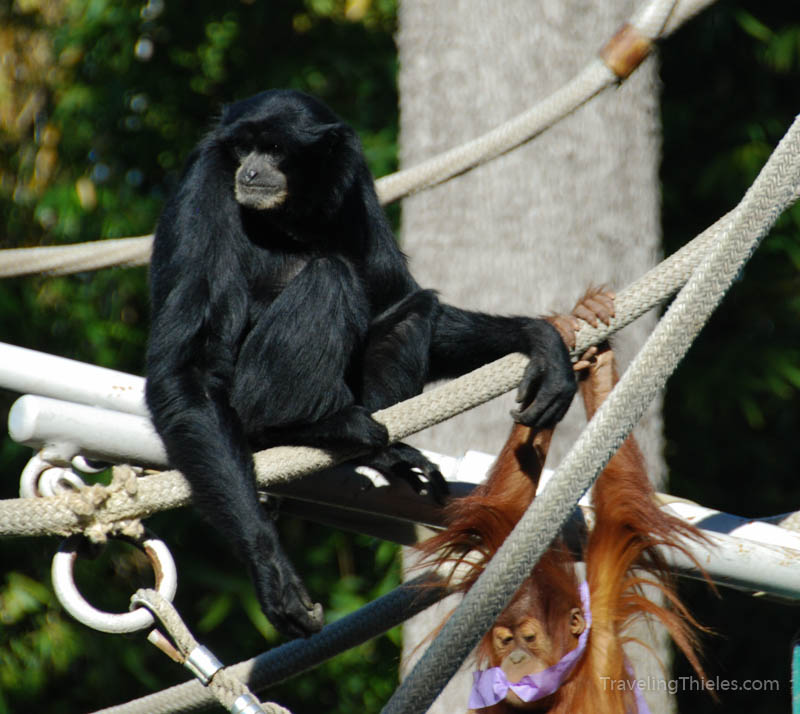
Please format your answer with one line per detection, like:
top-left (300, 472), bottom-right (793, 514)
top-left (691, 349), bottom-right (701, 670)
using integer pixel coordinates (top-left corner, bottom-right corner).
top-left (9, 395), bottom-right (800, 600)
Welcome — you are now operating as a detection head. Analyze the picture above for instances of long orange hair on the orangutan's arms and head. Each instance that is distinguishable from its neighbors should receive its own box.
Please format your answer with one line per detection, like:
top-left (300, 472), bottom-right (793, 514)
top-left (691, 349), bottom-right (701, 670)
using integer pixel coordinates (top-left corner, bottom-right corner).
top-left (419, 350), bottom-right (704, 714)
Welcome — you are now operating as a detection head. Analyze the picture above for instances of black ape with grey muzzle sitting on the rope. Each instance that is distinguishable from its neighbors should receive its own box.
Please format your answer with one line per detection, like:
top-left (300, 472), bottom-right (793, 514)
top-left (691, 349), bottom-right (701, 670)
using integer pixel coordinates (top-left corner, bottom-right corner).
top-left (147, 91), bottom-right (575, 635)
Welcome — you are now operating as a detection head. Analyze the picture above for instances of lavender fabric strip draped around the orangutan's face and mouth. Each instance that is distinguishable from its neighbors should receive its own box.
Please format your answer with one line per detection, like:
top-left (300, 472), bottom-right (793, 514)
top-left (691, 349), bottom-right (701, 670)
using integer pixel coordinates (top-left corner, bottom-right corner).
top-left (468, 582), bottom-right (592, 709)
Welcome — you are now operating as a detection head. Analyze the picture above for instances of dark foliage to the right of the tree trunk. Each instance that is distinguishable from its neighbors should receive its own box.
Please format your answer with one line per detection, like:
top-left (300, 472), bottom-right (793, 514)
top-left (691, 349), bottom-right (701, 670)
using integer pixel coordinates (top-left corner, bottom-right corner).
top-left (662, 0), bottom-right (800, 712)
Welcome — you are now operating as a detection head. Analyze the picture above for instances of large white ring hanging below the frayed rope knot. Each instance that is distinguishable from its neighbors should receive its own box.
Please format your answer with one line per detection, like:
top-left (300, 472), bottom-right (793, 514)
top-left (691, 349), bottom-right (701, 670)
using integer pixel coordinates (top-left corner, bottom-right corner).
top-left (51, 535), bottom-right (178, 634)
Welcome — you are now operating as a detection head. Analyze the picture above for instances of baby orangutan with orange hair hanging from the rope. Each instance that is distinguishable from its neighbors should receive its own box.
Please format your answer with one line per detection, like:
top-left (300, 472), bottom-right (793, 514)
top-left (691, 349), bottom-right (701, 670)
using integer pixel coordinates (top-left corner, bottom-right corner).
top-left (420, 291), bottom-right (703, 714)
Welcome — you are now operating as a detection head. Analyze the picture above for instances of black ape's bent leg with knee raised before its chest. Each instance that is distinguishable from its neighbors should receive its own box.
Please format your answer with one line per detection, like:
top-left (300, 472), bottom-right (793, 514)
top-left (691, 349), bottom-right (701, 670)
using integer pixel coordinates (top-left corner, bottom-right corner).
top-left (238, 258), bottom-right (387, 449)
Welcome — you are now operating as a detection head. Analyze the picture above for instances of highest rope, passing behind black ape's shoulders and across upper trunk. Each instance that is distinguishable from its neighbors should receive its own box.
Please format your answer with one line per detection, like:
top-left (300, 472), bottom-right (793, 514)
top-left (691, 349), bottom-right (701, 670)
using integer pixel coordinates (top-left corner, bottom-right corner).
top-left (0, 0), bottom-right (714, 278)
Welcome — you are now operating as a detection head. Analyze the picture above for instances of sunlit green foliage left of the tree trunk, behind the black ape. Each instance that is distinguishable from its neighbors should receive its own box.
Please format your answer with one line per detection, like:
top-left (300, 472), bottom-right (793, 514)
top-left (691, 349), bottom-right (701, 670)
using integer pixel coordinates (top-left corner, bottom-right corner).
top-left (0, 0), bottom-right (399, 714)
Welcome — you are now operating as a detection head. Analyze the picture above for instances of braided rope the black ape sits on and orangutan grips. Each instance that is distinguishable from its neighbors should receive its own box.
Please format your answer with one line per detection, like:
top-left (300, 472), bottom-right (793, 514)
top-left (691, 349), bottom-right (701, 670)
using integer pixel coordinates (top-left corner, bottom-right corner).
top-left (0, 193), bottom-right (797, 536)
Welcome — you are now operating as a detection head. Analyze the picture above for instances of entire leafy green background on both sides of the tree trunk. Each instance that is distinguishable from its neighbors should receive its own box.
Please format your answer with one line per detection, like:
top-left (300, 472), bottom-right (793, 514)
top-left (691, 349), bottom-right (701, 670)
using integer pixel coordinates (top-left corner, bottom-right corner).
top-left (0, 0), bottom-right (800, 714)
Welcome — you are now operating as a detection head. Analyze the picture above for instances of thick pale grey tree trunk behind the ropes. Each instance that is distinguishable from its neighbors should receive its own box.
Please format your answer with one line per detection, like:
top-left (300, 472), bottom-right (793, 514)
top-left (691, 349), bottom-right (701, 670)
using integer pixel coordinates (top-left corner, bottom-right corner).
top-left (398, 0), bottom-right (673, 714)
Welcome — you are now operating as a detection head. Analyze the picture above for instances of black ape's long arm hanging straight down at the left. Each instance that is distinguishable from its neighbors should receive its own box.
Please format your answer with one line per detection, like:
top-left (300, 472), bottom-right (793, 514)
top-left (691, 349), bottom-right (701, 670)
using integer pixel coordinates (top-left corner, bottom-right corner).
top-left (146, 164), bottom-right (322, 636)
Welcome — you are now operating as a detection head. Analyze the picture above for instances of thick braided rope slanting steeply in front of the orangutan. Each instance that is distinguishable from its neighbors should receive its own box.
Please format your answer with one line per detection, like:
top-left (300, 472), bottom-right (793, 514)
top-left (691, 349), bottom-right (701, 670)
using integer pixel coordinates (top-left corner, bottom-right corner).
top-left (383, 114), bottom-right (800, 714)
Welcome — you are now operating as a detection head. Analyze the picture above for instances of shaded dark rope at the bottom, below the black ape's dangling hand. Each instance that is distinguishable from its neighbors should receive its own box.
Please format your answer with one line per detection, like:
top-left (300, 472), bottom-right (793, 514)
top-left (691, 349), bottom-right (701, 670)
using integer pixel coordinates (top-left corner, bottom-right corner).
top-left (94, 575), bottom-right (447, 714)
